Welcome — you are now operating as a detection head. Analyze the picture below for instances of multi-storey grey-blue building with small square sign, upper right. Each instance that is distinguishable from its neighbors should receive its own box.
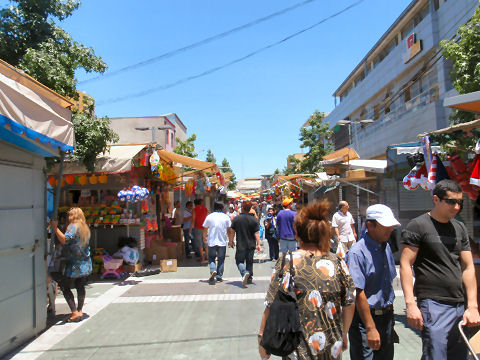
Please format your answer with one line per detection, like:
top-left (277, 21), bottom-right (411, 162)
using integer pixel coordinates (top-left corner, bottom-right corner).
top-left (326, 0), bottom-right (478, 159)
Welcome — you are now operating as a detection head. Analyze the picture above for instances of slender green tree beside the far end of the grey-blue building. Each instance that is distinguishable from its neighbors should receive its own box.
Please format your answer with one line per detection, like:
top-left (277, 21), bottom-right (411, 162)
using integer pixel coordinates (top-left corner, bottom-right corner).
top-left (298, 110), bottom-right (332, 174)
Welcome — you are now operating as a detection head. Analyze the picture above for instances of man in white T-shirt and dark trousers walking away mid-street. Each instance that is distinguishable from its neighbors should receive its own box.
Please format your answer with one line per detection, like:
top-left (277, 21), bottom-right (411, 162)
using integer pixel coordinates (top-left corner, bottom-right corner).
top-left (203, 202), bottom-right (232, 283)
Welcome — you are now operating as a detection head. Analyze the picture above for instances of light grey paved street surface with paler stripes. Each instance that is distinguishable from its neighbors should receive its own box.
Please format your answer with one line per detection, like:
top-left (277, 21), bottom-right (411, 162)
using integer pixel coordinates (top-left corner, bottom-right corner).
top-left (8, 245), bottom-right (421, 360)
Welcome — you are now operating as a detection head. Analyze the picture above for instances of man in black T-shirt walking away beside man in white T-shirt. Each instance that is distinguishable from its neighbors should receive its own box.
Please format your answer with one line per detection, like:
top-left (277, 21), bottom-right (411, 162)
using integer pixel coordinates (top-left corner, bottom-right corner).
top-left (228, 201), bottom-right (260, 286)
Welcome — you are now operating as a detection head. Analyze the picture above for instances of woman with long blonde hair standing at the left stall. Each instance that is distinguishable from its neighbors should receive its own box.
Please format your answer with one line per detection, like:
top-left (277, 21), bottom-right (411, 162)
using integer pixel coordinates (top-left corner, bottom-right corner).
top-left (51, 208), bottom-right (92, 322)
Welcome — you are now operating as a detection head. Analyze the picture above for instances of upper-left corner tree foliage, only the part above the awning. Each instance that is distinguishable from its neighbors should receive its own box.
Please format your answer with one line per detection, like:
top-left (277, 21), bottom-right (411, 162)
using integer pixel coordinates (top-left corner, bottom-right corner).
top-left (0, 0), bottom-right (107, 99)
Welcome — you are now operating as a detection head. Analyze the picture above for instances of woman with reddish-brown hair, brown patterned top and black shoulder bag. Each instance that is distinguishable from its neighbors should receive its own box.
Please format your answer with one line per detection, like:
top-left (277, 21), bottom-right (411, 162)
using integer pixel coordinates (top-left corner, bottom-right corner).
top-left (258, 200), bottom-right (355, 360)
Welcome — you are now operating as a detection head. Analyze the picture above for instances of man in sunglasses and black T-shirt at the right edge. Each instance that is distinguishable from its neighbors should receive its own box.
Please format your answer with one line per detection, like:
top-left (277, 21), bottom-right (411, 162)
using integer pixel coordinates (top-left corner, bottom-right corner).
top-left (400, 180), bottom-right (480, 360)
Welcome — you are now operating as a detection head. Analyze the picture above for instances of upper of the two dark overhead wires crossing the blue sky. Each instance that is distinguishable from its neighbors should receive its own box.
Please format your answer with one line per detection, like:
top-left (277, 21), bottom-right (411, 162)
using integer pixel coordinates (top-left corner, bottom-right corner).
top-left (78, 0), bottom-right (316, 85)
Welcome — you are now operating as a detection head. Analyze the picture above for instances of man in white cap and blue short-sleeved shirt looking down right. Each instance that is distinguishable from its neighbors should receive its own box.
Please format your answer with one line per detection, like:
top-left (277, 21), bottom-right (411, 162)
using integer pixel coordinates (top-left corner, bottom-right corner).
top-left (346, 204), bottom-right (400, 360)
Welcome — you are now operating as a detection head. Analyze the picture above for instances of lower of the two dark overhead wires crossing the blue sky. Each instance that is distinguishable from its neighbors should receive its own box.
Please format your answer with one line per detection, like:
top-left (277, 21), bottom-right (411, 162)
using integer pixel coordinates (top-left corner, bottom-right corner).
top-left (98, 0), bottom-right (365, 105)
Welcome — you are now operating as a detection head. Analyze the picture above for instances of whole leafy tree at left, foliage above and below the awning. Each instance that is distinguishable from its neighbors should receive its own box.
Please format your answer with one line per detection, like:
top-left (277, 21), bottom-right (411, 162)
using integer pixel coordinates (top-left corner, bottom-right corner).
top-left (0, 0), bottom-right (118, 171)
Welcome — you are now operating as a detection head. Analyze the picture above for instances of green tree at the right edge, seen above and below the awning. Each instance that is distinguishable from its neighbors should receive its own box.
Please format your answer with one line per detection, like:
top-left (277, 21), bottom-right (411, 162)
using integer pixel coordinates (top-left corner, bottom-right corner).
top-left (432, 6), bottom-right (480, 154)
